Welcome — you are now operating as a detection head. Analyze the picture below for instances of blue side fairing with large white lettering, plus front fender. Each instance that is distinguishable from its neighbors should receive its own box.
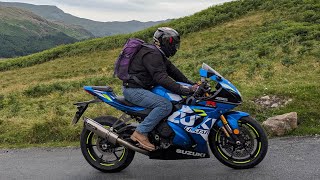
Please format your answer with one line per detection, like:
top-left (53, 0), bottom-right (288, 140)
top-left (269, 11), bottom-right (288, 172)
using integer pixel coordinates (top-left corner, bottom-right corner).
top-left (164, 103), bottom-right (249, 153)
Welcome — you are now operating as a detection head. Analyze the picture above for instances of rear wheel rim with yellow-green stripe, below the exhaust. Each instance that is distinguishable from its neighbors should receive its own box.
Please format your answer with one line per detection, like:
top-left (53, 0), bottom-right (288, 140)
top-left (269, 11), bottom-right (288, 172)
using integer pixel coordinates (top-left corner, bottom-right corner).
top-left (86, 129), bottom-right (127, 167)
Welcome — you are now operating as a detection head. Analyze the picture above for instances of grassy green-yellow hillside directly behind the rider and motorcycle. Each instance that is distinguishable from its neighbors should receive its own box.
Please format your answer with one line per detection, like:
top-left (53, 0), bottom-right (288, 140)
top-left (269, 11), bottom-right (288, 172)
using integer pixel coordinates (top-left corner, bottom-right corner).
top-left (0, 0), bottom-right (320, 146)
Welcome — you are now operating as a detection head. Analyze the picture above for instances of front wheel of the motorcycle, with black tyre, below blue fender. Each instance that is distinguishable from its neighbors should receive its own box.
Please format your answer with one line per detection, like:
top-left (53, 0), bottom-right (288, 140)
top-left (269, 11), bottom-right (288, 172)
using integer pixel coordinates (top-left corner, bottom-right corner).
top-left (209, 117), bottom-right (268, 169)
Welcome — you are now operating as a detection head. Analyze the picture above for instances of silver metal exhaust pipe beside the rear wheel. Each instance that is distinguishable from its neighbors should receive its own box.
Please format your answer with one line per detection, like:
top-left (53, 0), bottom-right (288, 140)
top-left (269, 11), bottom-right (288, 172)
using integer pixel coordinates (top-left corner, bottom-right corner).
top-left (83, 117), bottom-right (149, 155)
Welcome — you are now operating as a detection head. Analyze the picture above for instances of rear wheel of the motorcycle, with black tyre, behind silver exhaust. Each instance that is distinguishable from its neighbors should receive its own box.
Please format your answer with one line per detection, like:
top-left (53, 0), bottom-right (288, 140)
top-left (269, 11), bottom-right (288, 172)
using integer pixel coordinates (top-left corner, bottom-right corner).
top-left (80, 116), bottom-right (135, 172)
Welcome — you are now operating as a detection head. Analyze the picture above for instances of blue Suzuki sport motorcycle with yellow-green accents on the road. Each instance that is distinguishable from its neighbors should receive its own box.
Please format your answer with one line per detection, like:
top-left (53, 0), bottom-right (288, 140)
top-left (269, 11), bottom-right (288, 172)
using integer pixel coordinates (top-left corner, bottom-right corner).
top-left (72, 63), bottom-right (268, 172)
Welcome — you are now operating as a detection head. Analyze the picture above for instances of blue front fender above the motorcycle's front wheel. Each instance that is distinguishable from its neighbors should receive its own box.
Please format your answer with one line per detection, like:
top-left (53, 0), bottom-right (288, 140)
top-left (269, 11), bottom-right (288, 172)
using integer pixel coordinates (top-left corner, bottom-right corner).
top-left (216, 111), bottom-right (249, 129)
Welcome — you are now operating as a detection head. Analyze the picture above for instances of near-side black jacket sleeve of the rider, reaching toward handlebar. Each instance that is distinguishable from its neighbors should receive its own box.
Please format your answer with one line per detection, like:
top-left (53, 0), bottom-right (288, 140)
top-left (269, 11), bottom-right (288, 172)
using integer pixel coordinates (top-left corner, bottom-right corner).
top-left (143, 52), bottom-right (186, 95)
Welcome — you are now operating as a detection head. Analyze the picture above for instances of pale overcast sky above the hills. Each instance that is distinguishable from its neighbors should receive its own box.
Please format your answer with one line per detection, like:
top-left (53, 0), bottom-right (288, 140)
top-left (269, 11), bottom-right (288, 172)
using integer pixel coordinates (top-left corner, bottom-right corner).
top-left (0, 0), bottom-right (231, 21)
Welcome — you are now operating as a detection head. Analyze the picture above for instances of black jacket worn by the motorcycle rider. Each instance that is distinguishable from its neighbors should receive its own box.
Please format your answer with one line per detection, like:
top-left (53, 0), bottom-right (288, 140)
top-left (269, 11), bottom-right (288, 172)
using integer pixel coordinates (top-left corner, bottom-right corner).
top-left (124, 46), bottom-right (192, 95)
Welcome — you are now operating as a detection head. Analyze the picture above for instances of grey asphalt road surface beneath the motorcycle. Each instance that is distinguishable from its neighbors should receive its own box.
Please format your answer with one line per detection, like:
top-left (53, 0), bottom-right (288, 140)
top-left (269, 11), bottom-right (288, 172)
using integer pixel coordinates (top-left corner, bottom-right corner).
top-left (0, 136), bottom-right (320, 180)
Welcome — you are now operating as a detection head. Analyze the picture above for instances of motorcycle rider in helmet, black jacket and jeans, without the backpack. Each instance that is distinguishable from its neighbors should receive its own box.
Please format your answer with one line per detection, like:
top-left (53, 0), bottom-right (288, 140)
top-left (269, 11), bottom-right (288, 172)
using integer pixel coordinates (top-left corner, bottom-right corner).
top-left (123, 27), bottom-right (197, 151)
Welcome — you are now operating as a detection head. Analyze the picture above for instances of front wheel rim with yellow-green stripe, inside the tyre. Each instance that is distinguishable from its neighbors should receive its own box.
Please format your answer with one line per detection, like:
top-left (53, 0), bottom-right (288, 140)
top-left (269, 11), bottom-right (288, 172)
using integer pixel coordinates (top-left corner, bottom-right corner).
top-left (215, 121), bottom-right (261, 164)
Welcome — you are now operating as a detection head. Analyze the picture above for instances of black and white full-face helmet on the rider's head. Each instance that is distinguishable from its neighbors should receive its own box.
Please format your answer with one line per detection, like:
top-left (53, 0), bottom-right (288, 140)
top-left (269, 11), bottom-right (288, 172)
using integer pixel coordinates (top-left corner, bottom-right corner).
top-left (153, 27), bottom-right (180, 57)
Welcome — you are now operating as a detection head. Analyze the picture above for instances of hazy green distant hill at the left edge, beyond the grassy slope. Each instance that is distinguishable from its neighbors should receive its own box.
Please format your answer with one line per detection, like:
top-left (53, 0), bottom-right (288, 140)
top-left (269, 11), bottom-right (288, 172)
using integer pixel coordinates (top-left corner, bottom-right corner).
top-left (0, 6), bottom-right (93, 58)
